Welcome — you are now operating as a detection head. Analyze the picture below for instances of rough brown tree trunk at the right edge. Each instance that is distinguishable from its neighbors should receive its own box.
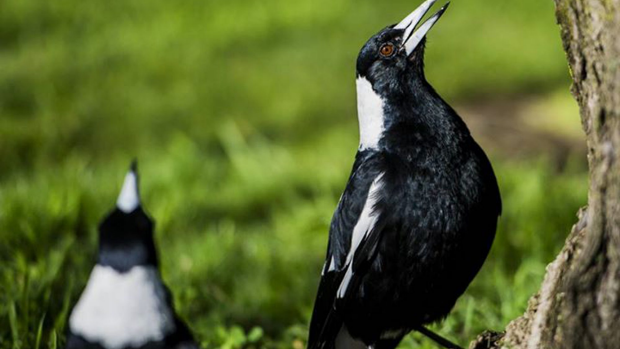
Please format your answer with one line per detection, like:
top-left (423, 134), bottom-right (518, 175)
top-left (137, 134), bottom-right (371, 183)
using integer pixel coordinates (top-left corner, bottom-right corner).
top-left (470, 0), bottom-right (620, 349)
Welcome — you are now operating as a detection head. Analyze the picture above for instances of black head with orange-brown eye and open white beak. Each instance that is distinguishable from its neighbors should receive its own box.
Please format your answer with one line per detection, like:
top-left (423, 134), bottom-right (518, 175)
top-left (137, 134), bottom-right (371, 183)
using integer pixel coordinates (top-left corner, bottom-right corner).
top-left (357, 0), bottom-right (449, 95)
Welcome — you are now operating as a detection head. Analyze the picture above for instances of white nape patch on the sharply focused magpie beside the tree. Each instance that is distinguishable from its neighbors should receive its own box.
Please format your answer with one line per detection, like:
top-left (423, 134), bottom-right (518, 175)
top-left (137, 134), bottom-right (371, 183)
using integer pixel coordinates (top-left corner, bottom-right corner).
top-left (356, 77), bottom-right (385, 150)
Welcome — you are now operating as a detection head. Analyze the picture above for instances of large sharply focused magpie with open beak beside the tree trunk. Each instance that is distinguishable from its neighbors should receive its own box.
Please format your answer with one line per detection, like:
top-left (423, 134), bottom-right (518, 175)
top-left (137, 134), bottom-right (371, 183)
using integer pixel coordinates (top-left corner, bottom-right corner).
top-left (308, 0), bottom-right (502, 349)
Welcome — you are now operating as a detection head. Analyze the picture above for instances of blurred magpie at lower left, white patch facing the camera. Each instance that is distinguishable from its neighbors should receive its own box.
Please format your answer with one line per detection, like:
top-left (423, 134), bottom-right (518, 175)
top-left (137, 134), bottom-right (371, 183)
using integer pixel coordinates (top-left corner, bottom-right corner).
top-left (66, 161), bottom-right (199, 349)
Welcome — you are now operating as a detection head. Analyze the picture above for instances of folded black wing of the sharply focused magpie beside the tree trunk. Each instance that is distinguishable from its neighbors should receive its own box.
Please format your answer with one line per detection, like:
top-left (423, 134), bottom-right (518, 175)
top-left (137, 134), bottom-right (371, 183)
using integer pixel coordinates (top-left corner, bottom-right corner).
top-left (308, 152), bottom-right (382, 349)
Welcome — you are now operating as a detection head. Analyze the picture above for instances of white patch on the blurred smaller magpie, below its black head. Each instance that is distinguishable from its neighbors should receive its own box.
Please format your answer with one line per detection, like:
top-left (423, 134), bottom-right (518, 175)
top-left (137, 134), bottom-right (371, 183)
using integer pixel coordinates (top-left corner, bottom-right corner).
top-left (69, 265), bottom-right (175, 349)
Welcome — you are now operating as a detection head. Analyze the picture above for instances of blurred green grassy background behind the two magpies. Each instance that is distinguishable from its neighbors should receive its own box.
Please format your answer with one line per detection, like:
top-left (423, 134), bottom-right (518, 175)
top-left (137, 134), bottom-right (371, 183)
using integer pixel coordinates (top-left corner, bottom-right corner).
top-left (0, 0), bottom-right (587, 349)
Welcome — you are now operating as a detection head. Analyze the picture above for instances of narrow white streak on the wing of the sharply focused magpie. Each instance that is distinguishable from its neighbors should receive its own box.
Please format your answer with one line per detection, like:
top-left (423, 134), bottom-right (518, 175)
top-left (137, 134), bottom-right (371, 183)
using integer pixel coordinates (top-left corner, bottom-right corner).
top-left (337, 174), bottom-right (383, 298)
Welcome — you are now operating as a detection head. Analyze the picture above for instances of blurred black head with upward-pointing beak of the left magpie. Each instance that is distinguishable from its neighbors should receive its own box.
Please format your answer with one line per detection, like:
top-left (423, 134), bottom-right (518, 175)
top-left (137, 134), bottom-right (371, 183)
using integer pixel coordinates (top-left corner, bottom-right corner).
top-left (98, 162), bottom-right (157, 272)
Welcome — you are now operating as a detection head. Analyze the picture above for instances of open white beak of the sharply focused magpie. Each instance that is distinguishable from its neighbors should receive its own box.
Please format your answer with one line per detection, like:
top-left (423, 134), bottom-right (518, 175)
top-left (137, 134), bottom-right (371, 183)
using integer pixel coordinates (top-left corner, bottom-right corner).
top-left (394, 0), bottom-right (450, 56)
